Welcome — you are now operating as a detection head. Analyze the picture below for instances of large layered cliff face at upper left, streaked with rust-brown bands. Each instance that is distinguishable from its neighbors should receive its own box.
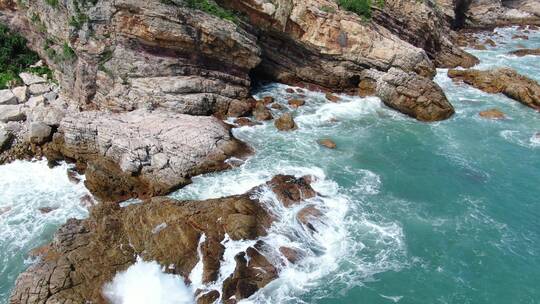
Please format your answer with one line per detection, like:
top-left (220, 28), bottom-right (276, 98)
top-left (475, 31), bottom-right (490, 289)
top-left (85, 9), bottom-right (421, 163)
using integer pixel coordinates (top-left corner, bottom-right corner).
top-left (2, 0), bottom-right (260, 115)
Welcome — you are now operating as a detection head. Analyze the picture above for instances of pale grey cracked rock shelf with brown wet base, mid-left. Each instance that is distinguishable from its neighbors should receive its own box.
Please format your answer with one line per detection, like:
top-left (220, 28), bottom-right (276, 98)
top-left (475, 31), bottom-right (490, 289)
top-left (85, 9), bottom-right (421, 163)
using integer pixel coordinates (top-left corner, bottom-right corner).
top-left (51, 110), bottom-right (246, 200)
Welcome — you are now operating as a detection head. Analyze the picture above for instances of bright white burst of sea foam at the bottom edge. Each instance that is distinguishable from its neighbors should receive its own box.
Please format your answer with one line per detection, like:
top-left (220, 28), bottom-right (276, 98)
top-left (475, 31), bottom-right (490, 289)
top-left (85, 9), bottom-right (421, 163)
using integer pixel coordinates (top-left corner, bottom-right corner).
top-left (103, 258), bottom-right (195, 304)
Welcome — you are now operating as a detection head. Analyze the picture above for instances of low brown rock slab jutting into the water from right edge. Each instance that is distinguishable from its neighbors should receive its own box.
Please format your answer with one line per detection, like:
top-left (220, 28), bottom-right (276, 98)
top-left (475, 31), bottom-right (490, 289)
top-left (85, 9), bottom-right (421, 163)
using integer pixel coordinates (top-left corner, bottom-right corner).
top-left (448, 68), bottom-right (540, 111)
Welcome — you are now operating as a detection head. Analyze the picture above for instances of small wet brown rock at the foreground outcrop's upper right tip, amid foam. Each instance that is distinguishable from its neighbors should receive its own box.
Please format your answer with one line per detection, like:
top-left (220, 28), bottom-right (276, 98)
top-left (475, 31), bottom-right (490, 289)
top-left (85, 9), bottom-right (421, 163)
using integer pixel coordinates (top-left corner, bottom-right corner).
top-left (267, 175), bottom-right (317, 207)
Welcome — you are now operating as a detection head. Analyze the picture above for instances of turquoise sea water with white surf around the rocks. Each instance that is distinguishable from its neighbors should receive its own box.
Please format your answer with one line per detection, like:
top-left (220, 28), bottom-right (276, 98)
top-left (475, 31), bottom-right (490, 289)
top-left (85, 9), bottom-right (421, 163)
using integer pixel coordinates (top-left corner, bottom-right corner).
top-left (0, 29), bottom-right (540, 304)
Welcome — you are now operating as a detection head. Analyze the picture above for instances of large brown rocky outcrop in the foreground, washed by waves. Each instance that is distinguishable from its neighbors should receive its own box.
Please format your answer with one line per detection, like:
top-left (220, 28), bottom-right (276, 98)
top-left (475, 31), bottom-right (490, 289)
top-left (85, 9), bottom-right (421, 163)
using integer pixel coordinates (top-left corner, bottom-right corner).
top-left (10, 176), bottom-right (315, 304)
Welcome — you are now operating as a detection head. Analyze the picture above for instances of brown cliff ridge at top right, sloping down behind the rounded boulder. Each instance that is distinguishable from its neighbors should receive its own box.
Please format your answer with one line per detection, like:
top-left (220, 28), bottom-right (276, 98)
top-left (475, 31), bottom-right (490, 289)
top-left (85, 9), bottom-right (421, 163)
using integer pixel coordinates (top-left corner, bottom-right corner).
top-left (374, 0), bottom-right (479, 68)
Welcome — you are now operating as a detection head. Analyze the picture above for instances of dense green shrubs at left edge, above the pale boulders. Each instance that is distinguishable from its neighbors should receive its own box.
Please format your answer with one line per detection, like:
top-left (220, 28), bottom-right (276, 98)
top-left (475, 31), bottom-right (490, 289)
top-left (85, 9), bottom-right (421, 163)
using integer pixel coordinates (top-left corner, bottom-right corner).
top-left (0, 24), bottom-right (52, 89)
